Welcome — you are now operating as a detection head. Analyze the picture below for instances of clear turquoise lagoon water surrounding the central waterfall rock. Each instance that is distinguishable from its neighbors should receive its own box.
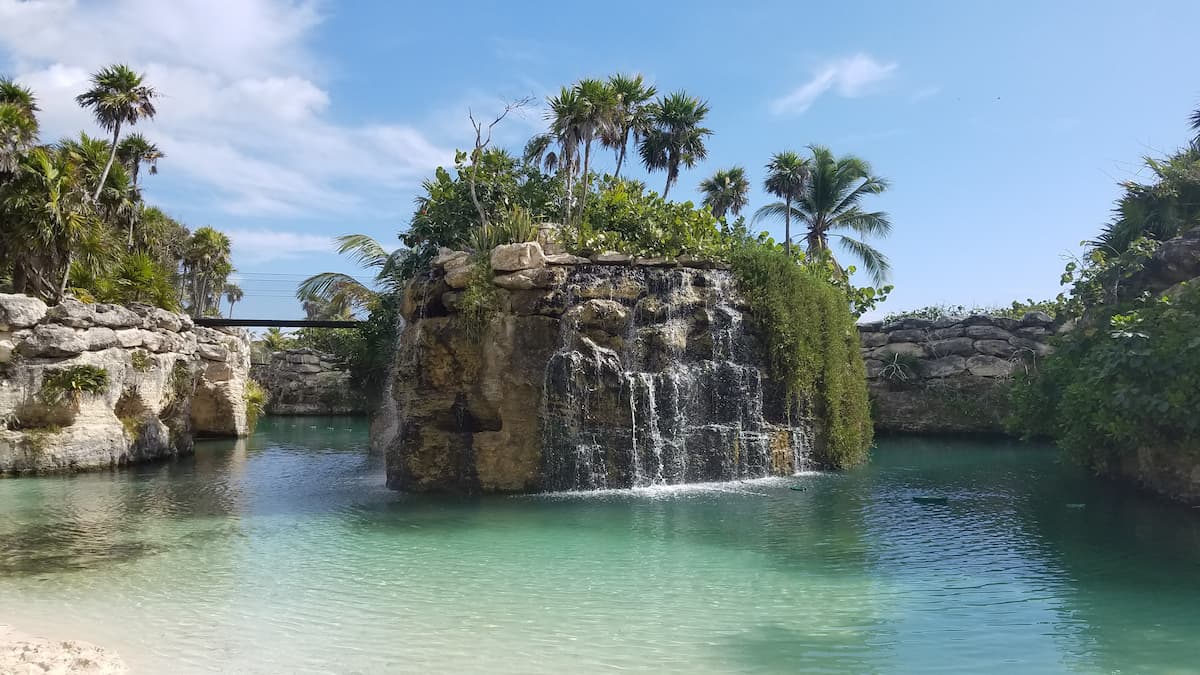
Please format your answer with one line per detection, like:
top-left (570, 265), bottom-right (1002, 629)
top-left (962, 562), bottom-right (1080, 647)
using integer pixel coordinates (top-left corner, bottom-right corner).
top-left (0, 418), bottom-right (1200, 673)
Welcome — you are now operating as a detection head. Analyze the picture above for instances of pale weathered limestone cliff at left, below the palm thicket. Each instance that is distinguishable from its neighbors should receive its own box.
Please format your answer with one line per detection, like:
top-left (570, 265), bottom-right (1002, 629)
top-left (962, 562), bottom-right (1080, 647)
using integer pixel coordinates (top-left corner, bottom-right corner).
top-left (0, 294), bottom-right (250, 473)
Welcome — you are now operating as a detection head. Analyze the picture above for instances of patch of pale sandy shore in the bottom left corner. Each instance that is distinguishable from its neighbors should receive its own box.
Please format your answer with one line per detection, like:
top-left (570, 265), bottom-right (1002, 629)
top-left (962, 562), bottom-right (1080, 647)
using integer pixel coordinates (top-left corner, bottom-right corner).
top-left (0, 623), bottom-right (130, 675)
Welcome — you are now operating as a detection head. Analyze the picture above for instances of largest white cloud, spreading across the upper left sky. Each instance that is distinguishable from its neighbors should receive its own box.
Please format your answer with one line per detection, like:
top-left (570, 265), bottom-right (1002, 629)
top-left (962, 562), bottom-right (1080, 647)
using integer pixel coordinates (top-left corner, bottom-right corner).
top-left (0, 0), bottom-right (452, 217)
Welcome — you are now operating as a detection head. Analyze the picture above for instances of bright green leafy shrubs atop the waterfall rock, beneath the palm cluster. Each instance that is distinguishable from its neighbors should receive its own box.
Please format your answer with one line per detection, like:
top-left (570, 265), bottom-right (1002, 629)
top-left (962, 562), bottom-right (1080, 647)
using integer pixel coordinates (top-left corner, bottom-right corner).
top-left (576, 178), bottom-right (728, 259)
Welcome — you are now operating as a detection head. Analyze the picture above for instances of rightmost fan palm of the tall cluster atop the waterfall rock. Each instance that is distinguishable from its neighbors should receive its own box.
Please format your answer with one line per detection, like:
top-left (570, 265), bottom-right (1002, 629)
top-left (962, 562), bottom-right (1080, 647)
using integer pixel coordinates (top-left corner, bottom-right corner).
top-left (638, 91), bottom-right (713, 199)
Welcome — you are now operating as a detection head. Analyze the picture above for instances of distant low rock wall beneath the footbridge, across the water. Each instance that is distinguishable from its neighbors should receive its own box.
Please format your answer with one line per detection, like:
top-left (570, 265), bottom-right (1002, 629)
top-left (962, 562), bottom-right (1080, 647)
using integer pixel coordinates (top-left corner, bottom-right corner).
top-left (251, 350), bottom-right (366, 414)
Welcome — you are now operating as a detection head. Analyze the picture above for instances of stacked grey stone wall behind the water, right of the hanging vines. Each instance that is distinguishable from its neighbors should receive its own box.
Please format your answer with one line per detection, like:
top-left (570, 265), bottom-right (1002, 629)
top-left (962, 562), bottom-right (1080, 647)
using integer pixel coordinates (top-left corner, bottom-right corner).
top-left (858, 312), bottom-right (1058, 434)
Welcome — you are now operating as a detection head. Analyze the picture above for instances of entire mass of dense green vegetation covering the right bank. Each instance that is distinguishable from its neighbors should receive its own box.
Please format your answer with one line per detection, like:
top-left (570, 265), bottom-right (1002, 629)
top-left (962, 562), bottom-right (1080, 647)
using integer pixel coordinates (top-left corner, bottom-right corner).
top-left (1012, 110), bottom-right (1200, 472)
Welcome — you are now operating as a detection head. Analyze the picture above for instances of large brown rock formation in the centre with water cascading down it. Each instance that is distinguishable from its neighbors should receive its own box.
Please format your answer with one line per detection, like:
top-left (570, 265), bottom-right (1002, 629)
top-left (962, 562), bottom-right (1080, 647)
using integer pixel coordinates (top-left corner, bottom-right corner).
top-left (385, 243), bottom-right (818, 492)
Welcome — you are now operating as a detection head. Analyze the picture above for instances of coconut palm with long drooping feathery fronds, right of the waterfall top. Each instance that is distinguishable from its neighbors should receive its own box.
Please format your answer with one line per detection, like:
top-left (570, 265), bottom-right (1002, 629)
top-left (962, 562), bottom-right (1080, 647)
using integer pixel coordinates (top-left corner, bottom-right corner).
top-left (755, 145), bottom-right (892, 285)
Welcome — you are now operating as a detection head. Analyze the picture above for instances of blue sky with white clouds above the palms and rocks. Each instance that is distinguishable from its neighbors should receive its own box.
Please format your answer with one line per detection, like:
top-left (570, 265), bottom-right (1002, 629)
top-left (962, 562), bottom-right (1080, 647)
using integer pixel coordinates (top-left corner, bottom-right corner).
top-left (0, 0), bottom-right (1200, 318)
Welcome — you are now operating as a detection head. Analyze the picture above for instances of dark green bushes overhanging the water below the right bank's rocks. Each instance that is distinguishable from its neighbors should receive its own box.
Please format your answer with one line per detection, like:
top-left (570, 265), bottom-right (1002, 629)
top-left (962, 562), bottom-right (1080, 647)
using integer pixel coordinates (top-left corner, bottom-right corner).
top-left (1012, 286), bottom-right (1200, 468)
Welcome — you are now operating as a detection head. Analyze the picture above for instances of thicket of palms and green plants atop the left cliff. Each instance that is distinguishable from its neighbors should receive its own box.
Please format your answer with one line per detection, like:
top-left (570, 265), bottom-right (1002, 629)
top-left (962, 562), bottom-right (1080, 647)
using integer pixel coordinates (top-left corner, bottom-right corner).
top-left (0, 65), bottom-right (233, 316)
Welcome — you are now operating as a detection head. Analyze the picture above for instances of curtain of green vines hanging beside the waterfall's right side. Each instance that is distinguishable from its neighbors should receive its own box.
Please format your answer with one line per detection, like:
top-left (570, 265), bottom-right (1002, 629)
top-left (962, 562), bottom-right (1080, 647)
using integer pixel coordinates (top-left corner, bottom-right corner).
top-left (730, 243), bottom-right (872, 467)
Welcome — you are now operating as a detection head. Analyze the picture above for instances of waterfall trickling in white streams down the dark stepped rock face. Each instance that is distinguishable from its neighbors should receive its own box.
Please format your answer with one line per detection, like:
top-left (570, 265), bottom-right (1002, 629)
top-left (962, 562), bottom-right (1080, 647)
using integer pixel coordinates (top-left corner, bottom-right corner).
top-left (541, 265), bottom-right (811, 490)
